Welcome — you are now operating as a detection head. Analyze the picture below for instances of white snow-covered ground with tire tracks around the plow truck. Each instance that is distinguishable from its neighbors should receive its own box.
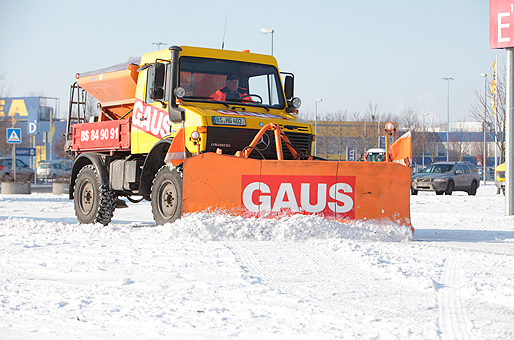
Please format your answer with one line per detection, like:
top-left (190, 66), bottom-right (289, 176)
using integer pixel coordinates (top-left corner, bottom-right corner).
top-left (0, 184), bottom-right (514, 339)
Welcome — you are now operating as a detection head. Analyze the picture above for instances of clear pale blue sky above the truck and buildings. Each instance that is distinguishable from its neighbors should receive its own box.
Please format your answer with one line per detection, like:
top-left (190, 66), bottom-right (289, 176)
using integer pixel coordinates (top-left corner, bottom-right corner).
top-left (0, 0), bottom-right (496, 125)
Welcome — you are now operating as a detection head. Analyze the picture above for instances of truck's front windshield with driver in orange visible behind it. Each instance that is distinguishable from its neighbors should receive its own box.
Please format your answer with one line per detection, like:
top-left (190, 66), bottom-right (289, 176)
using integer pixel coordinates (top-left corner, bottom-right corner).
top-left (179, 56), bottom-right (285, 109)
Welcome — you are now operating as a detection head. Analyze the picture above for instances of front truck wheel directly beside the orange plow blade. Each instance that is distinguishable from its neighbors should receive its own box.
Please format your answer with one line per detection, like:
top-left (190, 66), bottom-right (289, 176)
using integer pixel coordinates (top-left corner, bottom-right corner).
top-left (151, 165), bottom-right (182, 225)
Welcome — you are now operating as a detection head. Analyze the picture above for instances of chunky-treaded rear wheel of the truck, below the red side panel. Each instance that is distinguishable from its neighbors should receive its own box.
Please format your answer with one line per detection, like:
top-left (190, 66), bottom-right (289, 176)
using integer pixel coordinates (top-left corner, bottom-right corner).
top-left (73, 165), bottom-right (116, 225)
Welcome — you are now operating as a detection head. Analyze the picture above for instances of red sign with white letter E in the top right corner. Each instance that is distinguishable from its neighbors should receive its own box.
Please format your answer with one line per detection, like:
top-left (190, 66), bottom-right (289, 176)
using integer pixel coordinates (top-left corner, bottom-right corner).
top-left (489, 0), bottom-right (514, 48)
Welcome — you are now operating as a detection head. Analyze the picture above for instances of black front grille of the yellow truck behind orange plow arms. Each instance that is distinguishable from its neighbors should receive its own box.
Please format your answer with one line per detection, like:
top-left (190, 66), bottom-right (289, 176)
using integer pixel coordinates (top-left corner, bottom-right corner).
top-left (206, 127), bottom-right (312, 159)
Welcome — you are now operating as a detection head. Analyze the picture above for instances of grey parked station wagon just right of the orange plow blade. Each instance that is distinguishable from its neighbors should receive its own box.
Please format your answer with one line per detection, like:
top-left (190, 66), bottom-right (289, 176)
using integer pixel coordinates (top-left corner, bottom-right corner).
top-left (411, 162), bottom-right (480, 196)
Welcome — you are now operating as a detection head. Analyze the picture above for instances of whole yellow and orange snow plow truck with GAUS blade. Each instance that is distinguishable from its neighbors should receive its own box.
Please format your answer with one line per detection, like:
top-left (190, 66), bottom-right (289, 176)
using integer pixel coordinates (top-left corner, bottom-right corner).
top-left (65, 46), bottom-right (411, 225)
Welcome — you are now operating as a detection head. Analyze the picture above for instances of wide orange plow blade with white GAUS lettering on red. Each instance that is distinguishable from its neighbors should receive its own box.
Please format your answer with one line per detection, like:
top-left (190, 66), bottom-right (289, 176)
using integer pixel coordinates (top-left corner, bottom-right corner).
top-left (182, 153), bottom-right (411, 226)
